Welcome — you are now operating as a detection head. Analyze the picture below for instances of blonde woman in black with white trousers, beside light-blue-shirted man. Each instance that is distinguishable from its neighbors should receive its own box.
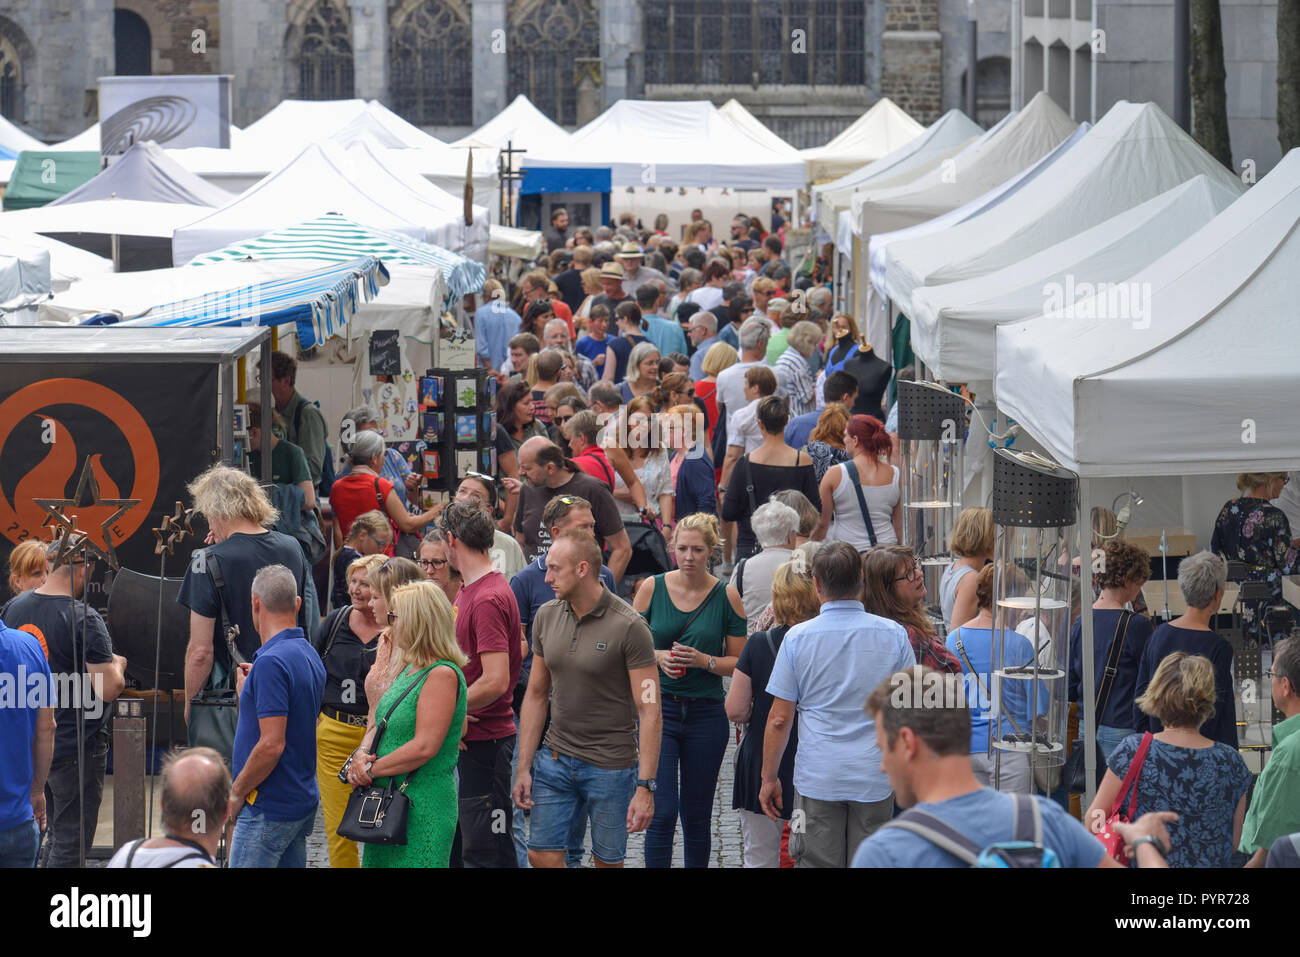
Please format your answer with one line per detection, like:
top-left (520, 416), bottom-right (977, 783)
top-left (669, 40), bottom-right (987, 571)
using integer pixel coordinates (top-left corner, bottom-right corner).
top-left (725, 555), bottom-right (822, 867)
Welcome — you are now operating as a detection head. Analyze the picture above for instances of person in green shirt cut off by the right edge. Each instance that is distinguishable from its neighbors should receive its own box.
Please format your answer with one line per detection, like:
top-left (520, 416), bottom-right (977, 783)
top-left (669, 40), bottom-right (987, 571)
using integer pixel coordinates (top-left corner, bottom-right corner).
top-left (1239, 638), bottom-right (1300, 867)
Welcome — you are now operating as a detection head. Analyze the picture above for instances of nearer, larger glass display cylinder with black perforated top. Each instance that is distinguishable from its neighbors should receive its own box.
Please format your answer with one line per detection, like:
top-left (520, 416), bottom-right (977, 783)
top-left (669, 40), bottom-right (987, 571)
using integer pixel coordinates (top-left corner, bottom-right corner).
top-left (988, 449), bottom-right (1079, 791)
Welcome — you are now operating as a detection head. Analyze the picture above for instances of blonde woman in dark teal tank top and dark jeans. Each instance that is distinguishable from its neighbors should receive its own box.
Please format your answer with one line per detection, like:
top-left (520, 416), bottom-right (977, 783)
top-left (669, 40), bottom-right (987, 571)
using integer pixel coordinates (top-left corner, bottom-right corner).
top-left (633, 512), bottom-right (745, 867)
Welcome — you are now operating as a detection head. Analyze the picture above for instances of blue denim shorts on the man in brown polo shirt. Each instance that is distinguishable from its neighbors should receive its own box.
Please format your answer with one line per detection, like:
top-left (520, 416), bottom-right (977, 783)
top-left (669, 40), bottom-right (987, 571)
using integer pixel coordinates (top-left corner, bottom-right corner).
top-left (528, 749), bottom-right (637, 863)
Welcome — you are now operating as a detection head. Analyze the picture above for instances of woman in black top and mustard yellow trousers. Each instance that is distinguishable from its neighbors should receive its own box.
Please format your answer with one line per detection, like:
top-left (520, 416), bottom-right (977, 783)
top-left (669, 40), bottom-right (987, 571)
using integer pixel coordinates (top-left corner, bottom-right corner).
top-left (315, 548), bottom-right (387, 867)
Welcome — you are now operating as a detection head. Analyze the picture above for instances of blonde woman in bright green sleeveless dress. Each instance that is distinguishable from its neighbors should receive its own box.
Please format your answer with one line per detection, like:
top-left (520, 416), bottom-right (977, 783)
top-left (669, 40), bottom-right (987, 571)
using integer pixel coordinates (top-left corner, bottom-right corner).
top-left (348, 581), bottom-right (467, 867)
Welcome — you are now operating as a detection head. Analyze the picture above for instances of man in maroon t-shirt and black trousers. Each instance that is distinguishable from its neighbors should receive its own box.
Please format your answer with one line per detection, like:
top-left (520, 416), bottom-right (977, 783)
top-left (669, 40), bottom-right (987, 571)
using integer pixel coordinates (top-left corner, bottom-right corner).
top-left (438, 502), bottom-right (524, 867)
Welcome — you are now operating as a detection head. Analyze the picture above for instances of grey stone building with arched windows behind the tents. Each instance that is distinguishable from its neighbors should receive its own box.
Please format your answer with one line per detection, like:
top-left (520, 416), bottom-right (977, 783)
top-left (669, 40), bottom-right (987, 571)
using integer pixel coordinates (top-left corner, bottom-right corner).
top-left (0, 0), bottom-right (1010, 147)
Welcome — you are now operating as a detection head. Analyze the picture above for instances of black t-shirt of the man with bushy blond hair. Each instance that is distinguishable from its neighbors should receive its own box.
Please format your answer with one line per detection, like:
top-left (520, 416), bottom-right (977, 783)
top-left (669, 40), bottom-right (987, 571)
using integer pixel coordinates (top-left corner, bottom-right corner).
top-left (176, 532), bottom-right (308, 667)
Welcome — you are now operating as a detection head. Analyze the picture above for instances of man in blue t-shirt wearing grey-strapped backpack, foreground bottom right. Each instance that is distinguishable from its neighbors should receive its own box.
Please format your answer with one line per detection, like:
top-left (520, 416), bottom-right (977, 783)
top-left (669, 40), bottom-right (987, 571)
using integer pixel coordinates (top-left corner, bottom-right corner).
top-left (853, 664), bottom-right (1178, 867)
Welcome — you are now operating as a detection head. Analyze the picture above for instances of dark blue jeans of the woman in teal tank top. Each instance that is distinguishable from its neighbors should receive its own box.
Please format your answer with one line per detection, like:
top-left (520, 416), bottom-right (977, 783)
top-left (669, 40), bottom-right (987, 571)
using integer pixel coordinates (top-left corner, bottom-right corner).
top-left (646, 694), bottom-right (731, 867)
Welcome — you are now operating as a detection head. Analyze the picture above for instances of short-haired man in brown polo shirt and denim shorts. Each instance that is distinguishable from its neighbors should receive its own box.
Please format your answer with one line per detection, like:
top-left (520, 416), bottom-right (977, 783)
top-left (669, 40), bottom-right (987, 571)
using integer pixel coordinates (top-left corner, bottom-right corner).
top-left (515, 531), bottom-right (660, 867)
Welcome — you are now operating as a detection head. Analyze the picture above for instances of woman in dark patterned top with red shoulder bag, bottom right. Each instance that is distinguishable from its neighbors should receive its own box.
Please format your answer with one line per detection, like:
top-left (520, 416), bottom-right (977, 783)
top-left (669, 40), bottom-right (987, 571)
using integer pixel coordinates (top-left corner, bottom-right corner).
top-left (1084, 651), bottom-right (1251, 867)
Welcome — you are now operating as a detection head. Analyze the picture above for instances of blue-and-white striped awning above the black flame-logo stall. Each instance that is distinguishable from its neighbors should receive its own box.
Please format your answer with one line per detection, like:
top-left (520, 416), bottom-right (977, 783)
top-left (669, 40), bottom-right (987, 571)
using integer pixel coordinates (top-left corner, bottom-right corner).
top-left (93, 256), bottom-right (389, 348)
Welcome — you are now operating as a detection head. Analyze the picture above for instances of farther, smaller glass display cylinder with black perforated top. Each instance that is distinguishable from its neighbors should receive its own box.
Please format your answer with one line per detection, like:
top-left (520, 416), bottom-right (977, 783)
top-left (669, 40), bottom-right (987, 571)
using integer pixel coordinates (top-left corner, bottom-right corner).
top-left (898, 382), bottom-right (966, 629)
